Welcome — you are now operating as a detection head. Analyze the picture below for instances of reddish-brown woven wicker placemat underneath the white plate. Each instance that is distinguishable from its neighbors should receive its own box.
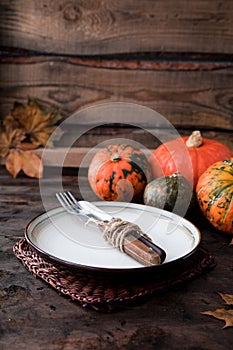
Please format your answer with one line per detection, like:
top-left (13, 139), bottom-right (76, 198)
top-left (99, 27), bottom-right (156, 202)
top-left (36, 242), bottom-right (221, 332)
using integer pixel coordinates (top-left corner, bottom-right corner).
top-left (13, 238), bottom-right (215, 312)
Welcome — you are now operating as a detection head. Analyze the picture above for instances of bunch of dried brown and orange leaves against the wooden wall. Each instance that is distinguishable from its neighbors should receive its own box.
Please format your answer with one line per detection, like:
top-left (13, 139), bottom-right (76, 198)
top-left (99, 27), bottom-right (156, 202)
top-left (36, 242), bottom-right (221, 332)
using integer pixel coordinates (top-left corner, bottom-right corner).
top-left (0, 99), bottom-right (63, 178)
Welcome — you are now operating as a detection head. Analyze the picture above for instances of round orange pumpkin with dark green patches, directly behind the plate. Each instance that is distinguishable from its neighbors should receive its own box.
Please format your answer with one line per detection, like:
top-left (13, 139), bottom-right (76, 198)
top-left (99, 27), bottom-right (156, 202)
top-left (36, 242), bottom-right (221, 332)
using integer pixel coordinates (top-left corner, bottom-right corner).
top-left (88, 144), bottom-right (151, 201)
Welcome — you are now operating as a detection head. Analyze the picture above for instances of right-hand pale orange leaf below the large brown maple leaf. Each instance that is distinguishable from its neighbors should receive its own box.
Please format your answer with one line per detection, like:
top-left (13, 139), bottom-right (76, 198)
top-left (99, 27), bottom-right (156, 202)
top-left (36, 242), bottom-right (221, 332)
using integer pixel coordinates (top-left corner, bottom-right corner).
top-left (21, 151), bottom-right (43, 179)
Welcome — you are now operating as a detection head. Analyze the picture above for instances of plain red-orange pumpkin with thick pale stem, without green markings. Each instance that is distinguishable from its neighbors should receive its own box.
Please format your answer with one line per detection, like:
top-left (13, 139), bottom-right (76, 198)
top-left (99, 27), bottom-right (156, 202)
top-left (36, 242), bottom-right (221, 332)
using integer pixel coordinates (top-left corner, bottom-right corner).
top-left (150, 131), bottom-right (232, 188)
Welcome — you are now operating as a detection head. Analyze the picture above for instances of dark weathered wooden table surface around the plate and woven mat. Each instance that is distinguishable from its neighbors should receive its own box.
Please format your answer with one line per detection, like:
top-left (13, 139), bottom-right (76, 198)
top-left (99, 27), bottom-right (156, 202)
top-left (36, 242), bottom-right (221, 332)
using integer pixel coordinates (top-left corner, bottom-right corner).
top-left (0, 167), bottom-right (233, 350)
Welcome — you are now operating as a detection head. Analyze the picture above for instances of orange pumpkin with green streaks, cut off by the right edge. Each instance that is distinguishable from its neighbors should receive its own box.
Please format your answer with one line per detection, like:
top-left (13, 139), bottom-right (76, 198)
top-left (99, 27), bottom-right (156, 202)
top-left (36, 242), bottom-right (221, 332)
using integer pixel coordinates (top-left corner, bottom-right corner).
top-left (196, 158), bottom-right (233, 234)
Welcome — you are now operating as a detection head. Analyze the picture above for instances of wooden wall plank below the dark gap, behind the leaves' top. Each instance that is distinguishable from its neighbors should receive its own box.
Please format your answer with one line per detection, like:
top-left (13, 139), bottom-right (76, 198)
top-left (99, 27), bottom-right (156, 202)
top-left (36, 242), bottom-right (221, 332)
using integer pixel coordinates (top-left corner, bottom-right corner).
top-left (0, 57), bottom-right (233, 131)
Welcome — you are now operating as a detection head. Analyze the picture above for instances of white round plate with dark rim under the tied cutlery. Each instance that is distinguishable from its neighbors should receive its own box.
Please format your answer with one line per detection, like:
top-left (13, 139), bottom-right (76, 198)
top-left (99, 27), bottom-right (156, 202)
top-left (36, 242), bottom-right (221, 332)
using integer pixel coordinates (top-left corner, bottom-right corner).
top-left (25, 202), bottom-right (201, 271)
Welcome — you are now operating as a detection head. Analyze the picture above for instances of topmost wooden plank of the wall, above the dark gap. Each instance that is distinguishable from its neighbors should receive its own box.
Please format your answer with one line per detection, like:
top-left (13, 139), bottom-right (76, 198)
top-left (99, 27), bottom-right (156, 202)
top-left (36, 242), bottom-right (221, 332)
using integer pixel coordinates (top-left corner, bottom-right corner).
top-left (0, 0), bottom-right (233, 55)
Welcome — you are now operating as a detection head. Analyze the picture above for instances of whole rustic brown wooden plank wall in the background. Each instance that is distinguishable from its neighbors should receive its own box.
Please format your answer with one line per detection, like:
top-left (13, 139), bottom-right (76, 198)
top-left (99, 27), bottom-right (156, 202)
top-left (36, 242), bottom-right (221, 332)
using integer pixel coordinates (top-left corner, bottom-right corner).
top-left (0, 0), bottom-right (233, 153)
